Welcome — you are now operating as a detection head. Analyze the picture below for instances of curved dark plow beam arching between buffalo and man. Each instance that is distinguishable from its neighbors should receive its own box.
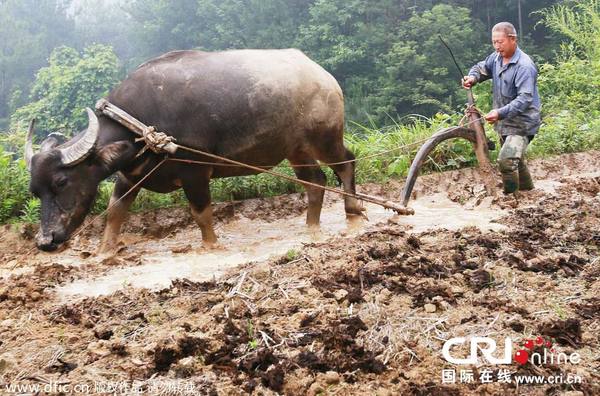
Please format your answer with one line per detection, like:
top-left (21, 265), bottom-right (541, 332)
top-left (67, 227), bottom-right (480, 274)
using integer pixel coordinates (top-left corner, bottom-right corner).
top-left (401, 127), bottom-right (477, 206)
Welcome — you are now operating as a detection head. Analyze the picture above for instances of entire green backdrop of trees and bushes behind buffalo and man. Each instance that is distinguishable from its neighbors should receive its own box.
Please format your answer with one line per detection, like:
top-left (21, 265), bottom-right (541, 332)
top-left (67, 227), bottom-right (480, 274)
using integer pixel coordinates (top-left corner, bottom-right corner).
top-left (0, 0), bottom-right (600, 223)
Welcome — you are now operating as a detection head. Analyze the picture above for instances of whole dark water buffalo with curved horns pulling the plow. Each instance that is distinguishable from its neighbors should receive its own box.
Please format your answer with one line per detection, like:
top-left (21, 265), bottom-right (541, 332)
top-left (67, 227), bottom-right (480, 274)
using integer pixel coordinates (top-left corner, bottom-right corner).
top-left (25, 49), bottom-right (361, 252)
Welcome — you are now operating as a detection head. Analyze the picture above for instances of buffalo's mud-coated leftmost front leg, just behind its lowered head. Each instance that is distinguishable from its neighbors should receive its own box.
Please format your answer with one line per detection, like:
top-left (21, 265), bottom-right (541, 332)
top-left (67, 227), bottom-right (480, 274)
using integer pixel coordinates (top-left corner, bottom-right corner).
top-left (98, 177), bottom-right (140, 253)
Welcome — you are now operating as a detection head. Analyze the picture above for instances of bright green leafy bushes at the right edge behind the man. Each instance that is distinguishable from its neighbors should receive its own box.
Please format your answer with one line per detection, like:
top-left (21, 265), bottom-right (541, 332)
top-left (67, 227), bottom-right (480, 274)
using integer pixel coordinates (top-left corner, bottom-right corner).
top-left (531, 0), bottom-right (600, 156)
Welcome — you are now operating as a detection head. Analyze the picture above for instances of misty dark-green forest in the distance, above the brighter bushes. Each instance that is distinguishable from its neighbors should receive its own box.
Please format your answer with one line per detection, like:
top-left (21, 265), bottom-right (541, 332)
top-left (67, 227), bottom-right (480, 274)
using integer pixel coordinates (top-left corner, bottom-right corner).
top-left (0, 0), bottom-right (568, 128)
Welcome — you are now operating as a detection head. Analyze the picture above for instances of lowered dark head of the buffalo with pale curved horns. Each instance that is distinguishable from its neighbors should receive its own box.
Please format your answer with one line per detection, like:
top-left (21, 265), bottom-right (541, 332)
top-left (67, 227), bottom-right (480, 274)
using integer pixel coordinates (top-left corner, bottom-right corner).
top-left (25, 109), bottom-right (131, 251)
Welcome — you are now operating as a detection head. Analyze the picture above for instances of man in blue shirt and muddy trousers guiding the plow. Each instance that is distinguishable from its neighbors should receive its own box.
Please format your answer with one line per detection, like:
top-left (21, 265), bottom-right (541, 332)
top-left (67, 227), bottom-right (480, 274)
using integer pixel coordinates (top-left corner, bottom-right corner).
top-left (463, 22), bottom-right (541, 194)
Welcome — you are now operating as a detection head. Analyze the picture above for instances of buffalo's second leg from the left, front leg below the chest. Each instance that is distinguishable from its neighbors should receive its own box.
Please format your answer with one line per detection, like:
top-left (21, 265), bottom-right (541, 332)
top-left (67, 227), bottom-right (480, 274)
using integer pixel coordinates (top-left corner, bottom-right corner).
top-left (183, 177), bottom-right (217, 247)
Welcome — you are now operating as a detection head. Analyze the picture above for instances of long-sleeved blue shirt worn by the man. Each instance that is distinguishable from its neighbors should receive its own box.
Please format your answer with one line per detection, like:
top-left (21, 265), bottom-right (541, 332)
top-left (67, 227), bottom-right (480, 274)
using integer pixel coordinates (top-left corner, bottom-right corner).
top-left (469, 48), bottom-right (542, 136)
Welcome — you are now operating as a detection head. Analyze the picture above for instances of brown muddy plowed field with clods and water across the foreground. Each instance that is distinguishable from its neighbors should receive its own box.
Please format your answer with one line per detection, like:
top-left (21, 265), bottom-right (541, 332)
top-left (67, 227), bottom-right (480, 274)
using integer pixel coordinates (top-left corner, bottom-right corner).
top-left (0, 152), bottom-right (600, 395)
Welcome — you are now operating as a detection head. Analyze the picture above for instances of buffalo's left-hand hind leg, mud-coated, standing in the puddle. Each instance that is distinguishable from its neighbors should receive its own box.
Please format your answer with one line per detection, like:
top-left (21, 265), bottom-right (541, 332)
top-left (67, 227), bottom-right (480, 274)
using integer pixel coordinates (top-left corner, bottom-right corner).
top-left (289, 156), bottom-right (327, 227)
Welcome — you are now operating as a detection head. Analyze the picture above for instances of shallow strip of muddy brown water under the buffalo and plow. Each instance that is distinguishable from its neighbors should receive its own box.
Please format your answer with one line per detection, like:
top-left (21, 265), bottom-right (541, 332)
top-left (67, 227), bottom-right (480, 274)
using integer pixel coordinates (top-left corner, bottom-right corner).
top-left (57, 194), bottom-right (505, 300)
